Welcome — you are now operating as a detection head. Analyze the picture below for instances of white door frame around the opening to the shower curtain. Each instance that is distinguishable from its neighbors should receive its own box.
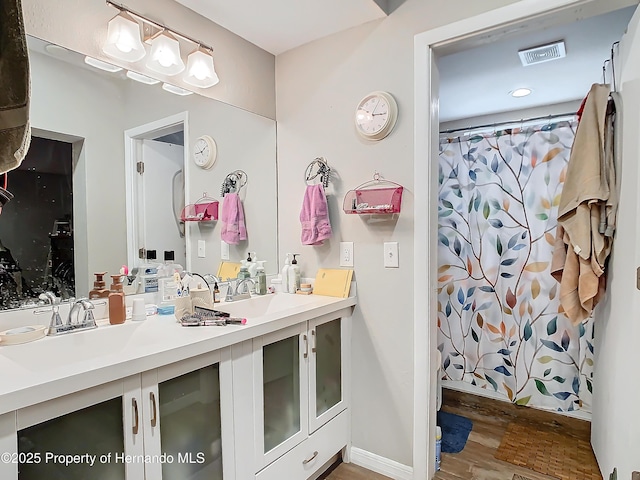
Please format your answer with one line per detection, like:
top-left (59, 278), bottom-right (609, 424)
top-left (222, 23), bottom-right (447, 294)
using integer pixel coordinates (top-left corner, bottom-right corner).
top-left (413, 0), bottom-right (637, 480)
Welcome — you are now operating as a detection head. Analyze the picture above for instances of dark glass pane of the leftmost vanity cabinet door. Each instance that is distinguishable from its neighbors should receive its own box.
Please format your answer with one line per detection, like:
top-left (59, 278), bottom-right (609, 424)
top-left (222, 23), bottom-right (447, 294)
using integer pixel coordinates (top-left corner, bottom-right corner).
top-left (18, 397), bottom-right (126, 480)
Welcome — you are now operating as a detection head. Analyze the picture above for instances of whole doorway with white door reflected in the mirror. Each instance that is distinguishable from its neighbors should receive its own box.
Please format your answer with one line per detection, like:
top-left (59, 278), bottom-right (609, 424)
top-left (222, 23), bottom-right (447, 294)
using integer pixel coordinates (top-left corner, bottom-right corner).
top-left (125, 112), bottom-right (190, 269)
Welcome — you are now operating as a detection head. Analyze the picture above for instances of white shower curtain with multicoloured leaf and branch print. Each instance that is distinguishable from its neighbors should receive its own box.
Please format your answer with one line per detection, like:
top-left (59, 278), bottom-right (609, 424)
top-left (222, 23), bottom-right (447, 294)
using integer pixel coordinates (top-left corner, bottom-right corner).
top-left (437, 122), bottom-right (593, 411)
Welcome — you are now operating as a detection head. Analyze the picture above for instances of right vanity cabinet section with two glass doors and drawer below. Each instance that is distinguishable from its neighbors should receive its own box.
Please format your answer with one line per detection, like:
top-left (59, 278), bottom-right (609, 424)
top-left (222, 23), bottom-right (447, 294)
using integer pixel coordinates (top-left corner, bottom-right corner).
top-left (252, 315), bottom-right (350, 480)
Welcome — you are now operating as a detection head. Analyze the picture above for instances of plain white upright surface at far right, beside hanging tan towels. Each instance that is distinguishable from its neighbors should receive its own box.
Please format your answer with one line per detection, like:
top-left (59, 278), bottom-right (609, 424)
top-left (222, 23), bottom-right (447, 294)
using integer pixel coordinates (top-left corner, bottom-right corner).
top-left (591, 5), bottom-right (640, 479)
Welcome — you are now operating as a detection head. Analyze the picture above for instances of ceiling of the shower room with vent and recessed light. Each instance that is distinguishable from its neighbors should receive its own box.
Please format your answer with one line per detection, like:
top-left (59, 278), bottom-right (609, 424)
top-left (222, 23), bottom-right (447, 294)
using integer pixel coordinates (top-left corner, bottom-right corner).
top-left (438, 7), bottom-right (635, 122)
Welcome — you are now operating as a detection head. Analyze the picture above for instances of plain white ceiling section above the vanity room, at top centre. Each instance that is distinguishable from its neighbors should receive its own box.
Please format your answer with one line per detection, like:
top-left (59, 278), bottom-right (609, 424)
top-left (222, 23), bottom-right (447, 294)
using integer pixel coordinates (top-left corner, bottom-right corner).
top-left (176, 0), bottom-right (388, 55)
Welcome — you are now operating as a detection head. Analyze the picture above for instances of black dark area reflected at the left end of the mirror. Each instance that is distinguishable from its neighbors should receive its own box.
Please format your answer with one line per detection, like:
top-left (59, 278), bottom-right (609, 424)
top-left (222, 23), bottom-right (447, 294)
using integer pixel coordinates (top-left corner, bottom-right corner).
top-left (0, 137), bottom-right (75, 309)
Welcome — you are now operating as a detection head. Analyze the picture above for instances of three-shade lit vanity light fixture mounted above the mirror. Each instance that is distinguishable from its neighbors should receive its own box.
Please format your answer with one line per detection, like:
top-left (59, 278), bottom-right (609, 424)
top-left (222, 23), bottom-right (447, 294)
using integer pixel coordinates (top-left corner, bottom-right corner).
top-left (103, 0), bottom-right (220, 88)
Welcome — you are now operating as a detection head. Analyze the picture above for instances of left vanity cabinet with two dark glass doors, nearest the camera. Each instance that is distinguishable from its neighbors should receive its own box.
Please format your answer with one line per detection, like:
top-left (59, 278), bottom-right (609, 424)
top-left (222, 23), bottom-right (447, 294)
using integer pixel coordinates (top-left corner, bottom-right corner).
top-left (10, 348), bottom-right (234, 480)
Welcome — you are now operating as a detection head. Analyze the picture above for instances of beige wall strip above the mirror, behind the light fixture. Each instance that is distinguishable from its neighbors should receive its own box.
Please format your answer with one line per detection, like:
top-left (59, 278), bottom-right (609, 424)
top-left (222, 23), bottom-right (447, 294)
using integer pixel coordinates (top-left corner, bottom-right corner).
top-left (22, 0), bottom-right (275, 118)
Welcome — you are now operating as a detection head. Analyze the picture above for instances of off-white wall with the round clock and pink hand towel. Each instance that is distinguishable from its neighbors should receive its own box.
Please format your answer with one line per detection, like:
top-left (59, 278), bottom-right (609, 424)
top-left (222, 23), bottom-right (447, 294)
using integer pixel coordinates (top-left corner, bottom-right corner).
top-left (276, 0), bottom-right (513, 465)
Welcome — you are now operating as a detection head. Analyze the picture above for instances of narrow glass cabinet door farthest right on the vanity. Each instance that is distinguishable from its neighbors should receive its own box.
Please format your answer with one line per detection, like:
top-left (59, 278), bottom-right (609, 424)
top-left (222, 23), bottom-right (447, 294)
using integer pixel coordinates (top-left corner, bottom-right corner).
top-left (309, 318), bottom-right (346, 432)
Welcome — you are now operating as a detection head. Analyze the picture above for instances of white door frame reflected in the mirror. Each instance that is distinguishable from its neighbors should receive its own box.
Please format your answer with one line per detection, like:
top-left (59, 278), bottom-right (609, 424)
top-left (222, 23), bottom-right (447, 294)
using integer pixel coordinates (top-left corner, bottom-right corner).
top-left (124, 112), bottom-right (191, 271)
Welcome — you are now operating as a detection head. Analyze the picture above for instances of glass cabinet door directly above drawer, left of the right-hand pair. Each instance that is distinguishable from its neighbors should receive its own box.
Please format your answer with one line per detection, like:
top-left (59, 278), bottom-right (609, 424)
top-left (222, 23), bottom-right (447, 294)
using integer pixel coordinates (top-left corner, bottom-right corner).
top-left (254, 325), bottom-right (309, 466)
